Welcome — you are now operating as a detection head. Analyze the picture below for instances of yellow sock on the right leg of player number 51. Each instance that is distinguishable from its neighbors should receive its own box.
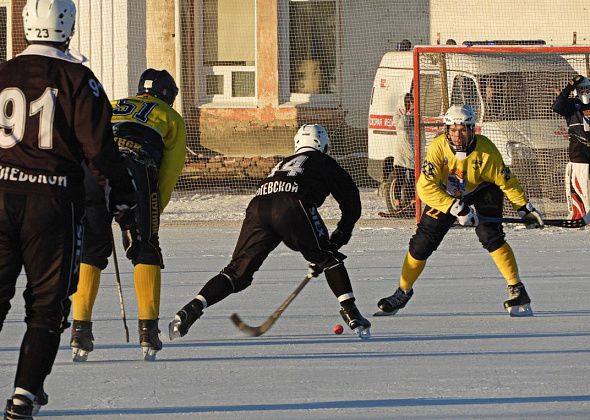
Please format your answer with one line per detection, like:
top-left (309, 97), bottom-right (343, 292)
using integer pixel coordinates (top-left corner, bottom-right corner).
top-left (133, 264), bottom-right (161, 320)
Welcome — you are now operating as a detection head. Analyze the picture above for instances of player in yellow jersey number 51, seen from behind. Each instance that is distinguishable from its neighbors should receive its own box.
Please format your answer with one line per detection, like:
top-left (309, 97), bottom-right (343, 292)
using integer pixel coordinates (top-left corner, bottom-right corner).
top-left (70, 69), bottom-right (186, 361)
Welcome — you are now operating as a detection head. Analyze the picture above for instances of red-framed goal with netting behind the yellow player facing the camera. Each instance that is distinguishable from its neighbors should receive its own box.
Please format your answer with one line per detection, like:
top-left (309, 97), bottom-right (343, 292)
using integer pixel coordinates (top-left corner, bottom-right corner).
top-left (412, 45), bottom-right (590, 217)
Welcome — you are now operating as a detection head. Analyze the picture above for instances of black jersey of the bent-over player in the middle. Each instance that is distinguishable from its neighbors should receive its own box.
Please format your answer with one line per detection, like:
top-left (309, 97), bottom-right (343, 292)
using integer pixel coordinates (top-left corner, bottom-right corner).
top-left (256, 150), bottom-right (361, 232)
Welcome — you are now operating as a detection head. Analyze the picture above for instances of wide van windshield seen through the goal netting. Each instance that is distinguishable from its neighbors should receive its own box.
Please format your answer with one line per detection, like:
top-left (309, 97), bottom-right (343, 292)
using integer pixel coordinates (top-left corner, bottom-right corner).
top-left (479, 72), bottom-right (569, 121)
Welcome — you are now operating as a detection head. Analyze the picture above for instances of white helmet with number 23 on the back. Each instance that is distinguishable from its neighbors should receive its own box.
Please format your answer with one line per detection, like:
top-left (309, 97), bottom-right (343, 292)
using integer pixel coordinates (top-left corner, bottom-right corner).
top-left (23, 0), bottom-right (76, 43)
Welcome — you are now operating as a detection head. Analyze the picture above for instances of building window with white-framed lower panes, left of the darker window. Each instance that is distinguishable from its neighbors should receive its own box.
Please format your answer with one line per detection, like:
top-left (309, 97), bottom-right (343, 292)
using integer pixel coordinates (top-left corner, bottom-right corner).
top-left (201, 0), bottom-right (256, 103)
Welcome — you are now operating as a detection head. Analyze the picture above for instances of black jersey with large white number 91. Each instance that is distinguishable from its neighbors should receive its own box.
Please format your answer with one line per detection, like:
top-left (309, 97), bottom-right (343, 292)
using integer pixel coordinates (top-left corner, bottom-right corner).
top-left (0, 45), bottom-right (130, 197)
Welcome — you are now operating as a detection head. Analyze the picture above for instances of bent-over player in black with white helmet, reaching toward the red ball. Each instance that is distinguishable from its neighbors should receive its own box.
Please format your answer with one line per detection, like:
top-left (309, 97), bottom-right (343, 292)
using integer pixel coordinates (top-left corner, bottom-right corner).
top-left (169, 124), bottom-right (371, 339)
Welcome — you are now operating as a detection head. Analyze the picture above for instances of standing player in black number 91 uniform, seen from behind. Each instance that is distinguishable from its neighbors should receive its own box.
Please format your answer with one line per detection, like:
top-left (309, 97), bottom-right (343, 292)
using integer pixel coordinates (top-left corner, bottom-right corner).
top-left (0, 0), bottom-right (135, 419)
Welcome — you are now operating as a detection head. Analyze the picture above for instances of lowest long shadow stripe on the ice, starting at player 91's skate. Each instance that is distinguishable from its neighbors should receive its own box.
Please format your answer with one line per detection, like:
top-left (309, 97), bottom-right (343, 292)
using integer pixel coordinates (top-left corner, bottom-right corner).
top-left (39, 395), bottom-right (590, 417)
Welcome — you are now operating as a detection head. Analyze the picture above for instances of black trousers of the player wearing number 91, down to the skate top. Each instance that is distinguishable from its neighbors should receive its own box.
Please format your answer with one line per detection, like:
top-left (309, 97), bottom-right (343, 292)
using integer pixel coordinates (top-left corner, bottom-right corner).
top-left (0, 192), bottom-right (83, 393)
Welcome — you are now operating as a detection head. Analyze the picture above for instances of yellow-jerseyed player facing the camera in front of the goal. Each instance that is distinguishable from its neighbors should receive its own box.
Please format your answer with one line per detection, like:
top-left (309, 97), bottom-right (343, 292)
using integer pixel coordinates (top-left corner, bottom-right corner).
top-left (375, 105), bottom-right (543, 316)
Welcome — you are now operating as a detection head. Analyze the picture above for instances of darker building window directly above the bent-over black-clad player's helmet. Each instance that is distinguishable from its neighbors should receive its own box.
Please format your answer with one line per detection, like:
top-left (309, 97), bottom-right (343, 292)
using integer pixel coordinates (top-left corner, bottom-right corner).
top-left (279, 0), bottom-right (339, 104)
